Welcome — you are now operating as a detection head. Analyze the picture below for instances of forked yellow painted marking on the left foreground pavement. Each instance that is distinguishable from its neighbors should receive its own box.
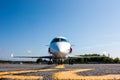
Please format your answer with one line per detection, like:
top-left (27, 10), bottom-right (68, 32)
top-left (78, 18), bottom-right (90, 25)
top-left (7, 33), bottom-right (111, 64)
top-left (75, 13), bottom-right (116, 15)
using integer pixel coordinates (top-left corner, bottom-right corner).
top-left (0, 69), bottom-right (57, 80)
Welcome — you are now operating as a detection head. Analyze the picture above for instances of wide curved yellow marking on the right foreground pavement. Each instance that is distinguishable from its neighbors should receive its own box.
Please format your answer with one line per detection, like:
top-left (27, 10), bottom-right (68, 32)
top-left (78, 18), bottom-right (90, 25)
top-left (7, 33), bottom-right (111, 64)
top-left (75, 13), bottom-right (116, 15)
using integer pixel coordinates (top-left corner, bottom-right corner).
top-left (52, 69), bottom-right (120, 80)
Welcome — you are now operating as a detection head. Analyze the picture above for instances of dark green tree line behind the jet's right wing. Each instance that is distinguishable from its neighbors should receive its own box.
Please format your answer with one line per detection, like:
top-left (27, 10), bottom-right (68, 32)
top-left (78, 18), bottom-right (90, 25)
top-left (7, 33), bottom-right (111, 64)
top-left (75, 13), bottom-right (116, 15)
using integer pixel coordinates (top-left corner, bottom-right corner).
top-left (66, 54), bottom-right (120, 64)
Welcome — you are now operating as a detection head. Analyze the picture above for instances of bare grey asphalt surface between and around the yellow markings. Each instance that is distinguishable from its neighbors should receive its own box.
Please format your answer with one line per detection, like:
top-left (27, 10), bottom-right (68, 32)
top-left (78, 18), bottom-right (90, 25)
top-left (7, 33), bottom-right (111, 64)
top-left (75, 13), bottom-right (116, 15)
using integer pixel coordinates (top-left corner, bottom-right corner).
top-left (0, 64), bottom-right (120, 80)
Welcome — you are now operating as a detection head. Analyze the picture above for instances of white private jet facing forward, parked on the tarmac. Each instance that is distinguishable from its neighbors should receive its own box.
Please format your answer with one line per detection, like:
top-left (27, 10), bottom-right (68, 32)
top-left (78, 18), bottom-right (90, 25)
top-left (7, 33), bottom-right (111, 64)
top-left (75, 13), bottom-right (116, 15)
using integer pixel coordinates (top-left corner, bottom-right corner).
top-left (11, 36), bottom-right (103, 64)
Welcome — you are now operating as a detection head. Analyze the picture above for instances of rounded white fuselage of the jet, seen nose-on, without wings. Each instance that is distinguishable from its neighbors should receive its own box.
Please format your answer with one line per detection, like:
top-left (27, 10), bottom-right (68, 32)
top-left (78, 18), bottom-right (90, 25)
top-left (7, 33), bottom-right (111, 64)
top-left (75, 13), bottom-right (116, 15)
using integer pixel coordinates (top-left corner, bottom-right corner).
top-left (49, 37), bottom-right (72, 58)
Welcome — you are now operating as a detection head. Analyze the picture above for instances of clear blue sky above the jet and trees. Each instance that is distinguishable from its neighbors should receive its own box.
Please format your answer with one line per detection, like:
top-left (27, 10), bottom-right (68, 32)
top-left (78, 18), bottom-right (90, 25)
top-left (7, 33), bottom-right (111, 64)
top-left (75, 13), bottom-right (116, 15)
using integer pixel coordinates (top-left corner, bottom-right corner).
top-left (0, 0), bottom-right (120, 59)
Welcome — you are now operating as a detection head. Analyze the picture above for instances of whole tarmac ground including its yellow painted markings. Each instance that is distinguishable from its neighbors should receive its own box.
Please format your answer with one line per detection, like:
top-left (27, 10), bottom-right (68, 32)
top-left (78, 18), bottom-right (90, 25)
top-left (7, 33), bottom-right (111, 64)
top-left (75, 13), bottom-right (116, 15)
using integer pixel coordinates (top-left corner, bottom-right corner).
top-left (0, 64), bottom-right (120, 80)
